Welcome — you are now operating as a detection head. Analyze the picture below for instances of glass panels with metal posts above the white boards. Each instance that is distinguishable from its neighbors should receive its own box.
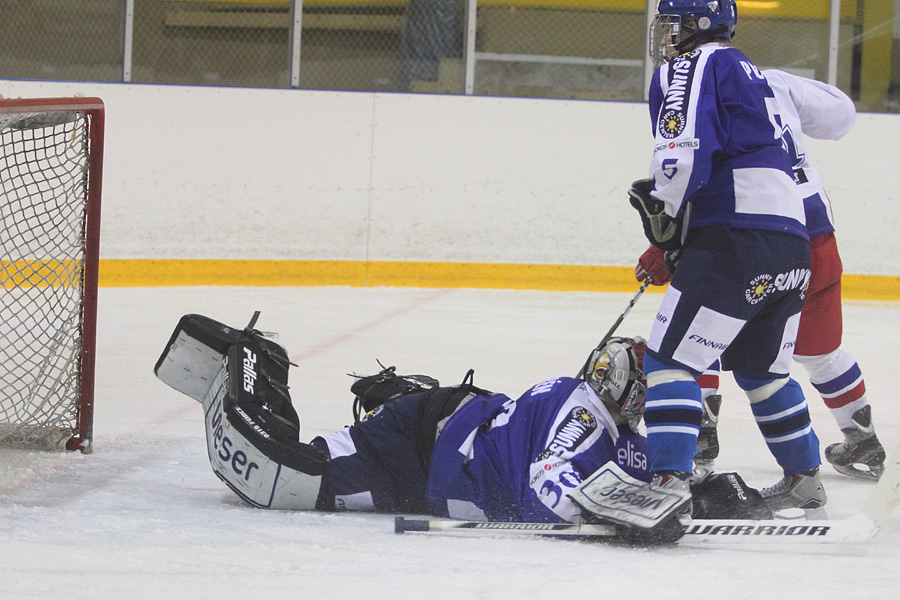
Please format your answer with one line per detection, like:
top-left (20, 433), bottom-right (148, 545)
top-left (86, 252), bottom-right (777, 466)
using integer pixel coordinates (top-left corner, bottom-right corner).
top-left (0, 0), bottom-right (900, 110)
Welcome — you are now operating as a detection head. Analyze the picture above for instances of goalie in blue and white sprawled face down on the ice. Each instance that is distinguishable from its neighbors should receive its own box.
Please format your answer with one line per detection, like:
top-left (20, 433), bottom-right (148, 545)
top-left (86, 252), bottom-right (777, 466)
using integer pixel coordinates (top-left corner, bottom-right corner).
top-left (155, 315), bottom-right (766, 522)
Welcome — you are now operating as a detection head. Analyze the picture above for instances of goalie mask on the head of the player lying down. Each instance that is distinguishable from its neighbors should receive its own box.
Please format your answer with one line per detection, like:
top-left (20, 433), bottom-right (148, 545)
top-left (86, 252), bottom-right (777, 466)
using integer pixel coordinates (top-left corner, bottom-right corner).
top-left (585, 337), bottom-right (647, 432)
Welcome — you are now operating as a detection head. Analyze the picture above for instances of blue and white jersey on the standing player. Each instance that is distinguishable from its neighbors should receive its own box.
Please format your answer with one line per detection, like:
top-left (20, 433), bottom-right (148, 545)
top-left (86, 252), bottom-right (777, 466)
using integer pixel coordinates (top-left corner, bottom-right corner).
top-left (650, 43), bottom-right (807, 238)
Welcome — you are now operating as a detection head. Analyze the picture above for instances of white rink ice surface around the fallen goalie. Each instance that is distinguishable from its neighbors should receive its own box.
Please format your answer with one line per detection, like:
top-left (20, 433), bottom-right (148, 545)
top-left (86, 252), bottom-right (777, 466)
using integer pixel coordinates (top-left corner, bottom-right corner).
top-left (0, 287), bottom-right (900, 600)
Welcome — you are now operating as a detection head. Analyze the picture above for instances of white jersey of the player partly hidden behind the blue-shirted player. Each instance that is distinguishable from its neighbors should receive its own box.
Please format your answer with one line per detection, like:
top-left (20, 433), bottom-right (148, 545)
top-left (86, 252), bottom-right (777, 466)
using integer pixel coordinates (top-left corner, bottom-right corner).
top-left (763, 69), bottom-right (856, 238)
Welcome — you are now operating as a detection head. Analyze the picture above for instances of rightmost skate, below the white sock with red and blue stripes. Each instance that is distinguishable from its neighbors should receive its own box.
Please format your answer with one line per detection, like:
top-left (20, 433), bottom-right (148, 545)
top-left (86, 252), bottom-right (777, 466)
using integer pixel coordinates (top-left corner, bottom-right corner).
top-left (825, 405), bottom-right (885, 481)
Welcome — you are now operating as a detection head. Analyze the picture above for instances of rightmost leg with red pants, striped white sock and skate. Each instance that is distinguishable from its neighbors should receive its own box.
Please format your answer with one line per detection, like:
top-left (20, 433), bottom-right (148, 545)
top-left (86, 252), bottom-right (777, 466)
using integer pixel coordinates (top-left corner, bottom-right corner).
top-left (794, 234), bottom-right (885, 479)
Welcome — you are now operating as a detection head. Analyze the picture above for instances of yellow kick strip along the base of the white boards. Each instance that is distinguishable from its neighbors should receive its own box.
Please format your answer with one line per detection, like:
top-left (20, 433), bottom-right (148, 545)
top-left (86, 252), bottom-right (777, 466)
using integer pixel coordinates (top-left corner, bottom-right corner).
top-left (100, 259), bottom-right (900, 301)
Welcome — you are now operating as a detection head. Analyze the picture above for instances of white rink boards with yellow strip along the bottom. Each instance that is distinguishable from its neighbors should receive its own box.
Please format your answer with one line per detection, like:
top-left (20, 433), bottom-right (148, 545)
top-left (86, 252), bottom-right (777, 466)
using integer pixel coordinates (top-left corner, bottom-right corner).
top-left (0, 80), bottom-right (900, 299)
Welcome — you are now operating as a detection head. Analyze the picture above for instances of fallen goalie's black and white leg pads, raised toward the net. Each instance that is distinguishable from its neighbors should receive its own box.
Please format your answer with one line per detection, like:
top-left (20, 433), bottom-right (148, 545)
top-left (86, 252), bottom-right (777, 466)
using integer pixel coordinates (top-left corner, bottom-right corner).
top-left (154, 313), bottom-right (329, 510)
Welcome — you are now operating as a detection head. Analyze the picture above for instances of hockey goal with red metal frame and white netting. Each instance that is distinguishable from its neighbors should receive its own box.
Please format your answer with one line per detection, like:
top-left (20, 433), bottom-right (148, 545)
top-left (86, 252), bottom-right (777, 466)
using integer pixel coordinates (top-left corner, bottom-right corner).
top-left (0, 97), bottom-right (105, 453)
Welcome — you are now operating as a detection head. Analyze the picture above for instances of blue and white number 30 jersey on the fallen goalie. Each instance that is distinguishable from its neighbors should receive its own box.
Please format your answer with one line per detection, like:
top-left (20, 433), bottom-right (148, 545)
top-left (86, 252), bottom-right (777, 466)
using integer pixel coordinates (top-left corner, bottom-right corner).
top-left (426, 377), bottom-right (651, 522)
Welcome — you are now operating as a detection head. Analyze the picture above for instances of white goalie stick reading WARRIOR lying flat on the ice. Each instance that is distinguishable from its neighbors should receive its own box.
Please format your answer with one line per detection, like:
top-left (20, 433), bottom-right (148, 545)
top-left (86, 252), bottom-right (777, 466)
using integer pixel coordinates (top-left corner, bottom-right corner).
top-left (394, 436), bottom-right (900, 546)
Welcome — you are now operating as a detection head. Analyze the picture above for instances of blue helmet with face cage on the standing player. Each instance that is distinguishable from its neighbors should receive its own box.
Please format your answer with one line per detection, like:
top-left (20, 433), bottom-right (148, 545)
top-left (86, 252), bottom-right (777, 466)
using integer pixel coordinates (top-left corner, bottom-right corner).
top-left (650, 0), bottom-right (737, 66)
